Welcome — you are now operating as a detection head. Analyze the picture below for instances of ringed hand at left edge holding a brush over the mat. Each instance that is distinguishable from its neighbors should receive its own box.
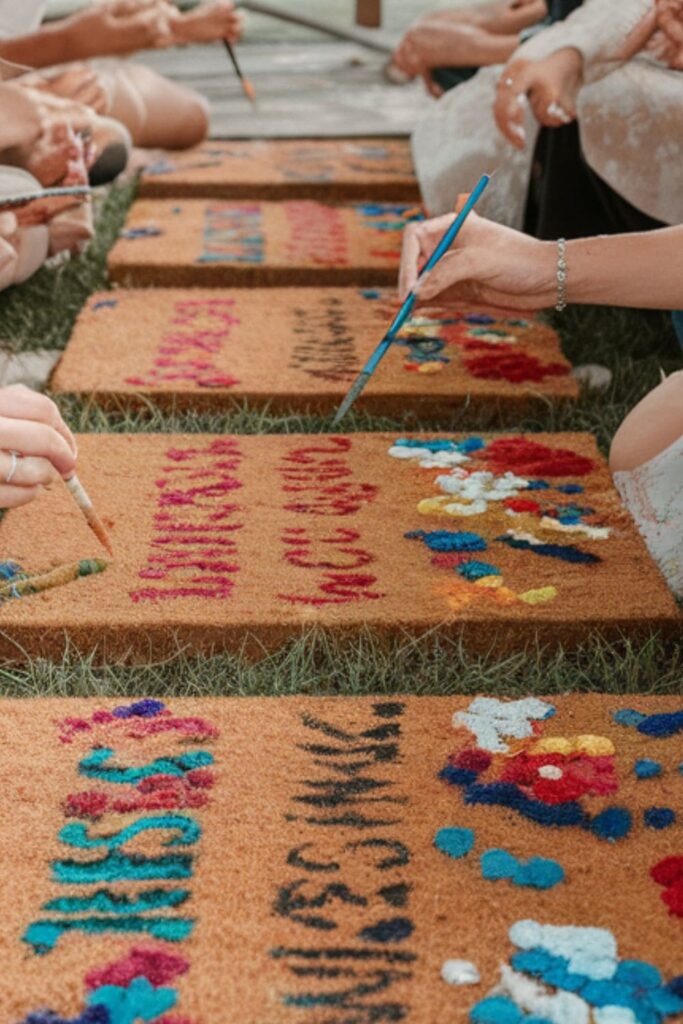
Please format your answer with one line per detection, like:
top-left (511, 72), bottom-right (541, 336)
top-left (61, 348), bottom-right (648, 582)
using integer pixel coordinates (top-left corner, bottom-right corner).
top-left (0, 384), bottom-right (77, 509)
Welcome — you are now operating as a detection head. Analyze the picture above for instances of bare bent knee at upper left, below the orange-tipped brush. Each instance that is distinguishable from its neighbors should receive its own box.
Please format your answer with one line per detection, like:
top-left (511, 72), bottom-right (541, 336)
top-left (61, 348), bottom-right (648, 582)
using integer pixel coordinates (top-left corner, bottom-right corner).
top-left (102, 65), bottom-right (209, 150)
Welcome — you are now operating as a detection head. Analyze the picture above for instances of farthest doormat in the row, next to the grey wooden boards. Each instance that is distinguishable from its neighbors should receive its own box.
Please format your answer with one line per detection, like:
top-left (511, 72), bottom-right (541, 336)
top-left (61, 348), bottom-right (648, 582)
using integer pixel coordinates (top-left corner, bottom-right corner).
top-left (138, 138), bottom-right (420, 203)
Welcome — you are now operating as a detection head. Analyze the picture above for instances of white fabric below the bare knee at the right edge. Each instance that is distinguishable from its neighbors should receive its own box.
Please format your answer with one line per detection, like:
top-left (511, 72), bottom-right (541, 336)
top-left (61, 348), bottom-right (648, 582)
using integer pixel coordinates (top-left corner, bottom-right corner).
top-left (614, 436), bottom-right (683, 597)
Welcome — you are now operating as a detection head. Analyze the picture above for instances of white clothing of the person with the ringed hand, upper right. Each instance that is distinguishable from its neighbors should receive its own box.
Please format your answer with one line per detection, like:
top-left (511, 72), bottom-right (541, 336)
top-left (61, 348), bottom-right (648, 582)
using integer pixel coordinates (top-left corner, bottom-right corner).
top-left (414, 0), bottom-right (683, 227)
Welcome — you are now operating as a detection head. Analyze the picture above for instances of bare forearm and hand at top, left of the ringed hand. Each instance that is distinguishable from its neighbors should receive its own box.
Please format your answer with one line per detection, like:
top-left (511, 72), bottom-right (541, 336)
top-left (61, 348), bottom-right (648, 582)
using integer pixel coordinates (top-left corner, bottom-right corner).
top-left (391, 0), bottom-right (548, 96)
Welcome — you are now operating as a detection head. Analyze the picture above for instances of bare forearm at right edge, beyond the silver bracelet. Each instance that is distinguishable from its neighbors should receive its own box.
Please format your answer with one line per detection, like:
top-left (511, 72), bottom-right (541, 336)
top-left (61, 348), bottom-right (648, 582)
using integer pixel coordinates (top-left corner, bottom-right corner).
top-left (567, 225), bottom-right (683, 309)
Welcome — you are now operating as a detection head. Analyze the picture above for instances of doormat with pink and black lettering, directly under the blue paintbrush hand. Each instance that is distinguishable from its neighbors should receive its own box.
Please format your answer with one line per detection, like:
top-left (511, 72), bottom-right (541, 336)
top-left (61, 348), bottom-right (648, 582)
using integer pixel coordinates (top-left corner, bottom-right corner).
top-left (52, 288), bottom-right (578, 414)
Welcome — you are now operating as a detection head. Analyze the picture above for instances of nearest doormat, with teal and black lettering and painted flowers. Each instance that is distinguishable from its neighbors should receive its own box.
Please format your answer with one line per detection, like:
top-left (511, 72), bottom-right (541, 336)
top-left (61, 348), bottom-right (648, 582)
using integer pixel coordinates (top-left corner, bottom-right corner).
top-left (0, 695), bottom-right (683, 1024)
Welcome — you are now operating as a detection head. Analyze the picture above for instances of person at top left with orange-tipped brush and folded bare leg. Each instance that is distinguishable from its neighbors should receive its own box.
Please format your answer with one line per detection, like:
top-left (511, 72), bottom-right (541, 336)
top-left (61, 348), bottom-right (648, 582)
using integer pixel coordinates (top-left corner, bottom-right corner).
top-left (0, 0), bottom-right (242, 150)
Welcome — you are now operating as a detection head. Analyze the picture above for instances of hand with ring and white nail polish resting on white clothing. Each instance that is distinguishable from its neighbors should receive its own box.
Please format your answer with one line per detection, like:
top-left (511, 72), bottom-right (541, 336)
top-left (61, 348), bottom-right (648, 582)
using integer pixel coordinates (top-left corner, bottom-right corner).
top-left (494, 46), bottom-right (584, 150)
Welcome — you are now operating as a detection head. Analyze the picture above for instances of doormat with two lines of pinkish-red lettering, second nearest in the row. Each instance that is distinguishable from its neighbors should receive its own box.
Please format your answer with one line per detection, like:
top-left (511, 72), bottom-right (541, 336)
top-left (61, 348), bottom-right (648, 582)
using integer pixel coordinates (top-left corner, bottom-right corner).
top-left (0, 434), bottom-right (680, 658)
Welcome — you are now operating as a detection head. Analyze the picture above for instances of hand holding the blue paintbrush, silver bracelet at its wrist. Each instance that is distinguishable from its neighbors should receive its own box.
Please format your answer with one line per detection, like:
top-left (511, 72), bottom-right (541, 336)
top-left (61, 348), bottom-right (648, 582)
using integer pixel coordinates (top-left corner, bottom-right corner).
top-left (398, 213), bottom-right (557, 309)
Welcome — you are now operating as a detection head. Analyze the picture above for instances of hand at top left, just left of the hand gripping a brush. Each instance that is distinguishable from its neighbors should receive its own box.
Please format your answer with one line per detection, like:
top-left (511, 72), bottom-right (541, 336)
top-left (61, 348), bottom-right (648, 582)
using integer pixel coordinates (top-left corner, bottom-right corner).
top-left (63, 0), bottom-right (177, 60)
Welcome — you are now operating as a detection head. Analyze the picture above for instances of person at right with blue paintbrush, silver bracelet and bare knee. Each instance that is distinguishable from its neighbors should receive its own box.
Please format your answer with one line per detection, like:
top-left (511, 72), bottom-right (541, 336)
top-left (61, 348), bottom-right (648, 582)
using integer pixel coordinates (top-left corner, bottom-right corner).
top-left (399, 213), bottom-right (683, 597)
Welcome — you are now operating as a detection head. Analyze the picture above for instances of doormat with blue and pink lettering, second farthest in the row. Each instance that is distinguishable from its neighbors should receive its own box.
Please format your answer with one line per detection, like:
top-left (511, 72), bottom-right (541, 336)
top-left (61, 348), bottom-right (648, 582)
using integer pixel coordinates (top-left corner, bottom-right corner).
top-left (109, 199), bottom-right (422, 288)
